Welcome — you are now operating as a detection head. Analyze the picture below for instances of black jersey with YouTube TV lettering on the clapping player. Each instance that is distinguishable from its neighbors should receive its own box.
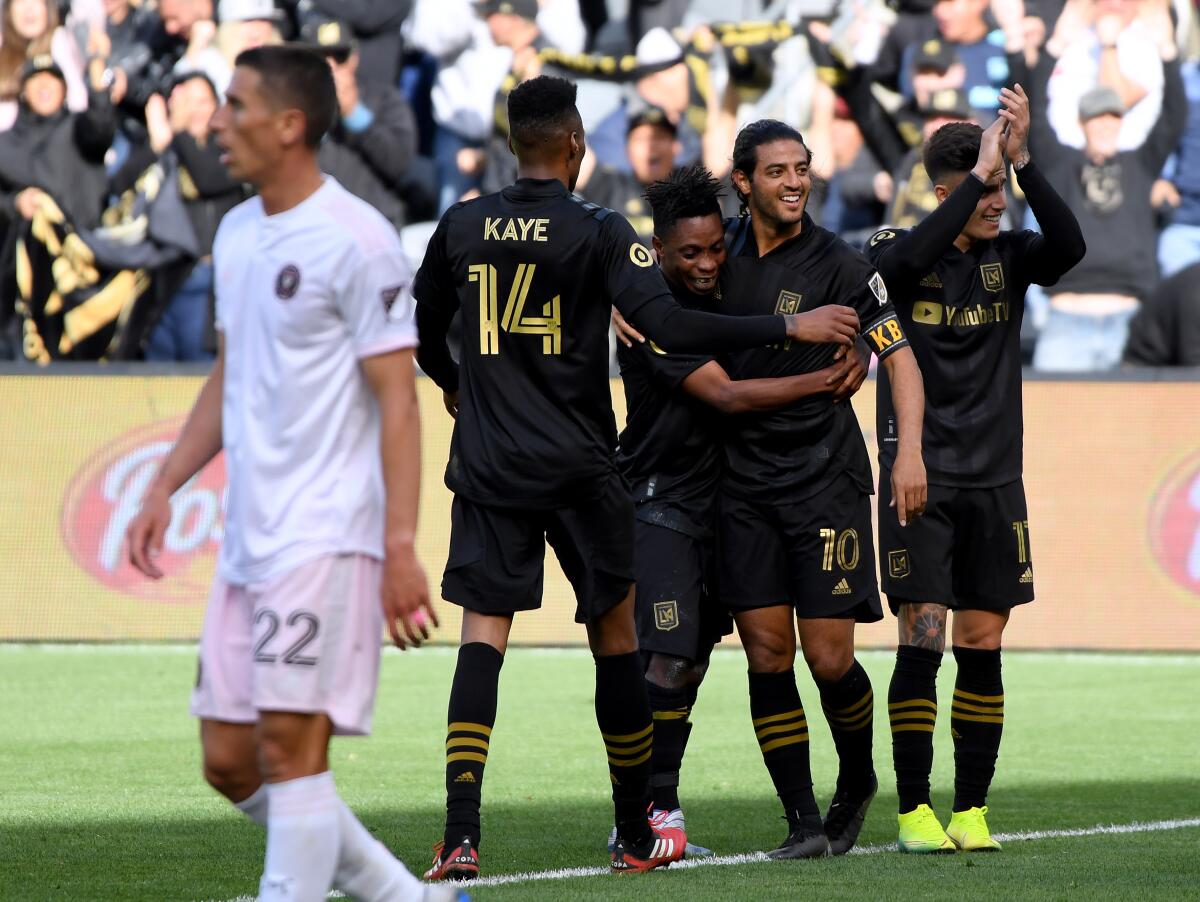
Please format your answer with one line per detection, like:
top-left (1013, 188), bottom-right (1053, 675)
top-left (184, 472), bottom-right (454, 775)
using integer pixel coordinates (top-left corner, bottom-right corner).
top-left (866, 229), bottom-right (1038, 488)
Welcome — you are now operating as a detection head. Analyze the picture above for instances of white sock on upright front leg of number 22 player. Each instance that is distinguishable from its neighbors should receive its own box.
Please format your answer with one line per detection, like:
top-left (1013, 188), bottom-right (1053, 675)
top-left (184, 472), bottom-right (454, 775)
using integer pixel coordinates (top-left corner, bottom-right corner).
top-left (258, 770), bottom-right (341, 902)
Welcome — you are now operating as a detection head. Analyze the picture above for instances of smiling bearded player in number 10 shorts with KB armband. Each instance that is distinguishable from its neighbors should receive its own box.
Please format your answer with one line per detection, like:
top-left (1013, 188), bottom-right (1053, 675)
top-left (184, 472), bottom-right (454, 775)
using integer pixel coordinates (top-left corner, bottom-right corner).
top-left (718, 120), bottom-right (925, 858)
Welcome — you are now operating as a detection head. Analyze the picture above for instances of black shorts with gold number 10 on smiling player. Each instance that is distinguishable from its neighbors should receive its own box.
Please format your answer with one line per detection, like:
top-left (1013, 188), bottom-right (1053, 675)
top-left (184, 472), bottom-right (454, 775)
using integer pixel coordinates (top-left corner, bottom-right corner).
top-left (716, 474), bottom-right (883, 624)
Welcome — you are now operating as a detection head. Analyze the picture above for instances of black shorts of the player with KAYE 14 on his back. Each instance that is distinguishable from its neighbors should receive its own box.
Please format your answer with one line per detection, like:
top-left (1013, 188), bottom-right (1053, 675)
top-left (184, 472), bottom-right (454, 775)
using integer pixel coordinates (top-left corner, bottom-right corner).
top-left (442, 473), bottom-right (634, 624)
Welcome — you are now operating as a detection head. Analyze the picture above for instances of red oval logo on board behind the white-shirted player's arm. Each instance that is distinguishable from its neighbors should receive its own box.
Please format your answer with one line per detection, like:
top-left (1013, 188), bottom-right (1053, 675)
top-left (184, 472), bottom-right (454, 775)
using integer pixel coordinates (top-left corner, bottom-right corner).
top-left (61, 416), bottom-right (226, 603)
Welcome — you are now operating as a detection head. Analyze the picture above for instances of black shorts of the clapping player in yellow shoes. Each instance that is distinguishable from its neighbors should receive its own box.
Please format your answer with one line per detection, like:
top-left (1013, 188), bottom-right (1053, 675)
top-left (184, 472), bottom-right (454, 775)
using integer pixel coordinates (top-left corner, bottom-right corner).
top-left (880, 469), bottom-right (1033, 613)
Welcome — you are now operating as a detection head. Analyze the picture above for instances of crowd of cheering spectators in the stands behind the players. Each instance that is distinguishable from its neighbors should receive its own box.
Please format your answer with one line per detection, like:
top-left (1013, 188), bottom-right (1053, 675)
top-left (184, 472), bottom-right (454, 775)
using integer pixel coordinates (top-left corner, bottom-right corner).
top-left (0, 0), bottom-right (1200, 372)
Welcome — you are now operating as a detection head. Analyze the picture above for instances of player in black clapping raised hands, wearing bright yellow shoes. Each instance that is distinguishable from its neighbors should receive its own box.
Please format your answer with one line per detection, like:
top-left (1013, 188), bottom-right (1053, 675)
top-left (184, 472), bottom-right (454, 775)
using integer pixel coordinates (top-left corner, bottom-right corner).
top-left (866, 85), bottom-right (1085, 852)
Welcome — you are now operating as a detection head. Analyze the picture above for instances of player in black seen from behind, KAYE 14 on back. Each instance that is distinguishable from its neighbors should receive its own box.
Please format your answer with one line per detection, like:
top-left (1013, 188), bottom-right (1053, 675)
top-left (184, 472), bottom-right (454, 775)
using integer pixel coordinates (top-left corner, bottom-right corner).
top-left (413, 77), bottom-right (825, 879)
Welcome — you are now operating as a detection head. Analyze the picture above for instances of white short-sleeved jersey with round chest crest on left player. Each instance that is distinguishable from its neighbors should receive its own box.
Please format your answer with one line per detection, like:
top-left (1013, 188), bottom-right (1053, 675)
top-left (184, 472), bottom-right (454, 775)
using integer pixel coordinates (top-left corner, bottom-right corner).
top-left (212, 176), bottom-right (416, 584)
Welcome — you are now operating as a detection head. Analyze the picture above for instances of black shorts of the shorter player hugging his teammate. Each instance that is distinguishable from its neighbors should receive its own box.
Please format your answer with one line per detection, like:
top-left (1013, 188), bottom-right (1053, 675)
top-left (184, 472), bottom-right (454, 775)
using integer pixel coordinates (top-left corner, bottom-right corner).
top-left (634, 521), bottom-right (733, 663)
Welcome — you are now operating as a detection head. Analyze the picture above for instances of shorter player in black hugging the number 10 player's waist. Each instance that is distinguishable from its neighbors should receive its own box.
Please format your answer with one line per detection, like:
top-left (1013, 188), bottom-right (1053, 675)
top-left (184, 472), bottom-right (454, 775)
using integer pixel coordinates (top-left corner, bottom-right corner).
top-left (617, 166), bottom-right (866, 856)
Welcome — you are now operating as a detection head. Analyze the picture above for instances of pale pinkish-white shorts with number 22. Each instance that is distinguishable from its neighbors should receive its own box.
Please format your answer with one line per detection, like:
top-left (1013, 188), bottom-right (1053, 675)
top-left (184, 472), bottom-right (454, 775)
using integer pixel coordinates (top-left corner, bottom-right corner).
top-left (192, 554), bottom-right (383, 735)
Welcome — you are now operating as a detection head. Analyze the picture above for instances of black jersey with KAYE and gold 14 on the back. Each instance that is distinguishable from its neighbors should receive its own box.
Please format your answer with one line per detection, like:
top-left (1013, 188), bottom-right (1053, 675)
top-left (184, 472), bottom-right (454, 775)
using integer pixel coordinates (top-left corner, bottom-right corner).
top-left (413, 179), bottom-right (670, 509)
